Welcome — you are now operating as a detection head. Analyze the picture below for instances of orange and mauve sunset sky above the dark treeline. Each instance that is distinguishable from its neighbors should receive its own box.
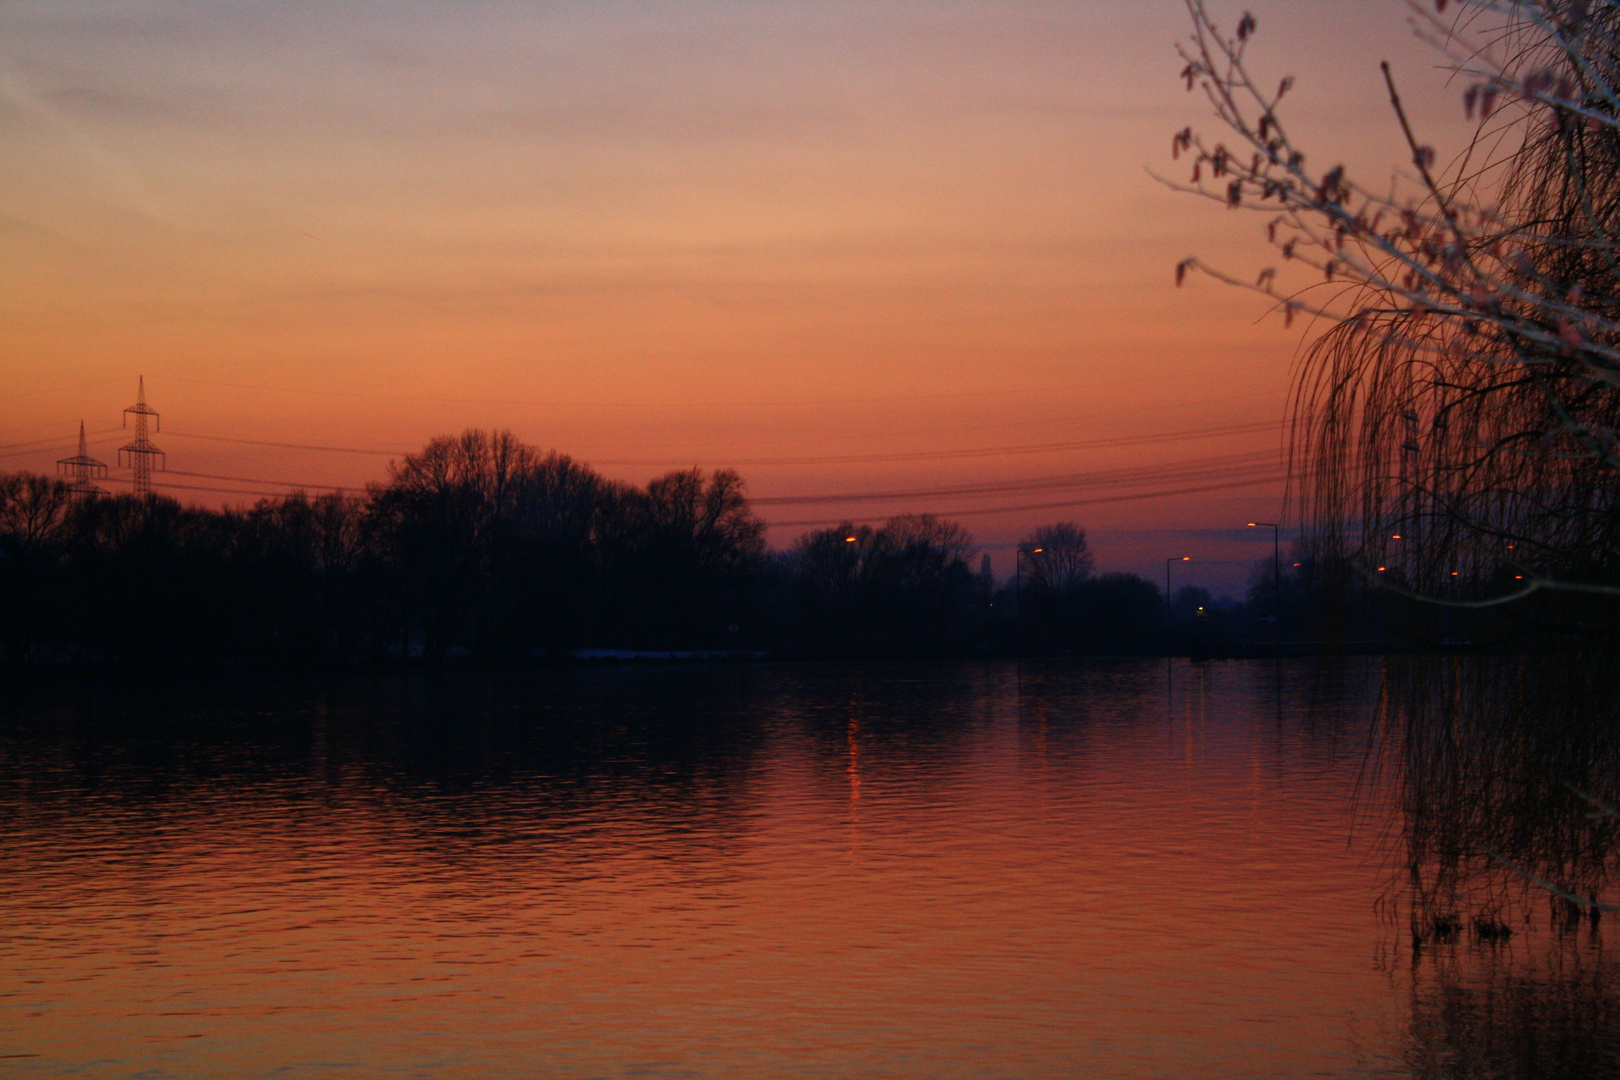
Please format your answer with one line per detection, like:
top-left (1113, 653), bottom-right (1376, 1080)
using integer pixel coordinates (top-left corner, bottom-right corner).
top-left (0, 0), bottom-right (1466, 596)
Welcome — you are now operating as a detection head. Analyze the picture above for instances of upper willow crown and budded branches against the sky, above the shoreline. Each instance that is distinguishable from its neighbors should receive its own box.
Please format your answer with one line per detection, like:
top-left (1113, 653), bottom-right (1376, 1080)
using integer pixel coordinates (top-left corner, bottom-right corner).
top-left (1173, 0), bottom-right (1620, 602)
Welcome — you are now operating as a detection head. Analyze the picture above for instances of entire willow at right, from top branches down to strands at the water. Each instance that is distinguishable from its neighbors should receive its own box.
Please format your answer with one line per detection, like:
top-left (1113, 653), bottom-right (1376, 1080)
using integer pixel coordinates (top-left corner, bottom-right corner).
top-left (1173, 0), bottom-right (1620, 947)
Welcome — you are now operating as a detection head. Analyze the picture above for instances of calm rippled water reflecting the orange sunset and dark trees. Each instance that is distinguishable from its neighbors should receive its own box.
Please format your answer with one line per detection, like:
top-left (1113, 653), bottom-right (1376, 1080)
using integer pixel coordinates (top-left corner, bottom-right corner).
top-left (0, 661), bottom-right (1620, 1078)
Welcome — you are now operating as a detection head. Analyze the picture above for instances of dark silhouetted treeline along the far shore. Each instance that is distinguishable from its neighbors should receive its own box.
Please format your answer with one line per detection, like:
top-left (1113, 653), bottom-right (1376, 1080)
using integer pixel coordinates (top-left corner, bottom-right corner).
top-left (0, 431), bottom-right (1568, 667)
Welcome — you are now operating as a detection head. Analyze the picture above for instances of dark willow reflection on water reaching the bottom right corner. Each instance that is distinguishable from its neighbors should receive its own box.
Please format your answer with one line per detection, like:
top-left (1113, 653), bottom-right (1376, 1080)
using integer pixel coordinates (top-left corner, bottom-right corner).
top-left (1374, 653), bottom-right (1620, 1078)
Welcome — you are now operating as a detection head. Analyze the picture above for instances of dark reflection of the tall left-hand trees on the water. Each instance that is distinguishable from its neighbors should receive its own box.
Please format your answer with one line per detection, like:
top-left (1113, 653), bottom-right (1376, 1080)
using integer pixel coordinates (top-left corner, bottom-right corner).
top-left (0, 669), bottom-right (763, 860)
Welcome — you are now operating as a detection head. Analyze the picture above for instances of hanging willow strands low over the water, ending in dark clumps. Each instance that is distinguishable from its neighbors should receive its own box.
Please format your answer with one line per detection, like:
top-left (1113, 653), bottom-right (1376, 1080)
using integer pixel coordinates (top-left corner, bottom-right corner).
top-left (1380, 653), bottom-right (1620, 941)
